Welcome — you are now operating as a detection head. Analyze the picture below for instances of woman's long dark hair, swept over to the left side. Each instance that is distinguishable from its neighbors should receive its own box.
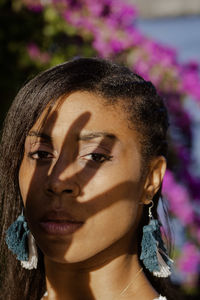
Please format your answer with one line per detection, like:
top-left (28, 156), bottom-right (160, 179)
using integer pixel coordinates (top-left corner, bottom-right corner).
top-left (0, 58), bottom-right (172, 300)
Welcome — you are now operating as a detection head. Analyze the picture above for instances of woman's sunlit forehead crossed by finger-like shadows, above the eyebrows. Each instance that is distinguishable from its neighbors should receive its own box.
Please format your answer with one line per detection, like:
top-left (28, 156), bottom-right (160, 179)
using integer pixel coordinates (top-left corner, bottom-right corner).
top-left (32, 91), bottom-right (138, 144)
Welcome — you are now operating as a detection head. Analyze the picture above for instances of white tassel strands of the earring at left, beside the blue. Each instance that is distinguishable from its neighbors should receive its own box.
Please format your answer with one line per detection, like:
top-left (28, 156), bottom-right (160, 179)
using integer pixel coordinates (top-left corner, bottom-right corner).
top-left (21, 232), bottom-right (38, 270)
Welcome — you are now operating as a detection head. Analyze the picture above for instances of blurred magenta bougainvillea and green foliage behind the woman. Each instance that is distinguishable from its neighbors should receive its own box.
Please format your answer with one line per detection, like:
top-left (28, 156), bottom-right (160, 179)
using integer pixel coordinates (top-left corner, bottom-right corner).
top-left (0, 0), bottom-right (200, 299)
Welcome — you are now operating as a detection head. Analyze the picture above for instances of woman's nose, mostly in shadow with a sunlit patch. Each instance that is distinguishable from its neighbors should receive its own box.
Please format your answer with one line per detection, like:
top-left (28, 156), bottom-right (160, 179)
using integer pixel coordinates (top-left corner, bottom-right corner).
top-left (45, 165), bottom-right (80, 197)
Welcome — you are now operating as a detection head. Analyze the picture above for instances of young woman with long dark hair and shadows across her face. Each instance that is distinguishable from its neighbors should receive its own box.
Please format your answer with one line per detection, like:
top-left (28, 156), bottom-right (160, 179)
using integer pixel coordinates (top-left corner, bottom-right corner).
top-left (0, 58), bottom-right (173, 300)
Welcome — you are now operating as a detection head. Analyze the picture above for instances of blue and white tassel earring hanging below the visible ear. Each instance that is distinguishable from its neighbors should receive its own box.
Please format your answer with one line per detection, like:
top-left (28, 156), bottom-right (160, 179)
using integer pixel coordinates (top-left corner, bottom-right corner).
top-left (140, 200), bottom-right (173, 277)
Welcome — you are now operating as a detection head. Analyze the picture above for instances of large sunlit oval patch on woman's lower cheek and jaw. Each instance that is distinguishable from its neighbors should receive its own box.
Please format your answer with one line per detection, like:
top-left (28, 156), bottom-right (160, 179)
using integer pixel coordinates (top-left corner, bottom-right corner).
top-left (61, 195), bottom-right (140, 262)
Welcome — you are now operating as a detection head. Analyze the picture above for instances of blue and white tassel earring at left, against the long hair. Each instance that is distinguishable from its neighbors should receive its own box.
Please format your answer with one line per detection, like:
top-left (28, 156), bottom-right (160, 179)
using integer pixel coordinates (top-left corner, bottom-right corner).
top-left (6, 213), bottom-right (38, 270)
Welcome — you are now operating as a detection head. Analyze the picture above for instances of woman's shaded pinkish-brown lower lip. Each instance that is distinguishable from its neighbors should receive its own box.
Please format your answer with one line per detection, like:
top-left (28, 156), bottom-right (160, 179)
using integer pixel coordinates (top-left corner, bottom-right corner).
top-left (40, 221), bottom-right (83, 235)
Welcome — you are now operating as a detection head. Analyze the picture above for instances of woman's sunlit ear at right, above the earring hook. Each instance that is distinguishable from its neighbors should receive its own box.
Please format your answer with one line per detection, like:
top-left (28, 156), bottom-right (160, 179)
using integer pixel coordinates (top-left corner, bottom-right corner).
top-left (142, 156), bottom-right (167, 204)
